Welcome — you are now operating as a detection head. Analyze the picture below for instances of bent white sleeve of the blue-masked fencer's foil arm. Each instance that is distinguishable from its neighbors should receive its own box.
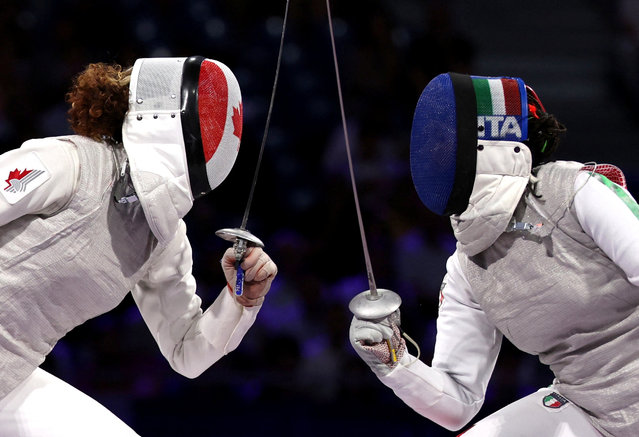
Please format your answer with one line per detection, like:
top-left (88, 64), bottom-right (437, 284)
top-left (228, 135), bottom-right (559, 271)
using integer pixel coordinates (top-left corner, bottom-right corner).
top-left (380, 253), bottom-right (502, 430)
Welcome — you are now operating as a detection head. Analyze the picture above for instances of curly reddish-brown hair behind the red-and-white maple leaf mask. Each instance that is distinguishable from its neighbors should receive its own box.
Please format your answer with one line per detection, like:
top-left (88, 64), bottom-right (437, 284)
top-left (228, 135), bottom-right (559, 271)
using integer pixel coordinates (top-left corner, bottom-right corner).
top-left (66, 63), bottom-right (131, 144)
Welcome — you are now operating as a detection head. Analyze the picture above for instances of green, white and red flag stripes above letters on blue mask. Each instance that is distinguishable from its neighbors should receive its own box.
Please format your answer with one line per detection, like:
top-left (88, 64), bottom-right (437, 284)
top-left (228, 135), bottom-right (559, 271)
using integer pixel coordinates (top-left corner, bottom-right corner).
top-left (473, 78), bottom-right (521, 115)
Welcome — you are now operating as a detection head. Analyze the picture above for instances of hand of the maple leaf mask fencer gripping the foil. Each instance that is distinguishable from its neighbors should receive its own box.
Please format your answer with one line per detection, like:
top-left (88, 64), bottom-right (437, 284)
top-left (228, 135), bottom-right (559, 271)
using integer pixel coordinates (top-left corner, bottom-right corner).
top-left (222, 247), bottom-right (277, 307)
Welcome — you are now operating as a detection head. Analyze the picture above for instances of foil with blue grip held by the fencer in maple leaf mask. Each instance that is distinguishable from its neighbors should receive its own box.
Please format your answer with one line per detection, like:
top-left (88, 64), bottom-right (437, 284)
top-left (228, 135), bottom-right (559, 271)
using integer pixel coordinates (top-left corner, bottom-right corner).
top-left (215, 0), bottom-right (289, 296)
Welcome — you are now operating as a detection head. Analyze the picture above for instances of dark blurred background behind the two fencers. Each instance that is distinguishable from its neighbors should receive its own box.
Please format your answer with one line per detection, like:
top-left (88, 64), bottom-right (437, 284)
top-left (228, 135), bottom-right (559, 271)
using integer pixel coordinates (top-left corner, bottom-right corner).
top-left (0, 0), bottom-right (639, 437)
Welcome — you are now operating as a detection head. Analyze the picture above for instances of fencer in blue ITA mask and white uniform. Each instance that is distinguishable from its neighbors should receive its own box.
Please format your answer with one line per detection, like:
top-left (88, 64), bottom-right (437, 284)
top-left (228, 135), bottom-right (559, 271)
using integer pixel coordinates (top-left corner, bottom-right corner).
top-left (350, 73), bottom-right (639, 437)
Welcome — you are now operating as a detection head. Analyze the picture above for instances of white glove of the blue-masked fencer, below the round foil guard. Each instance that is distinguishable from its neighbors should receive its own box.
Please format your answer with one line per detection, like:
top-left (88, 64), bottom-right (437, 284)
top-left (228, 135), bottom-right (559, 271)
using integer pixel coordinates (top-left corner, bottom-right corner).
top-left (349, 309), bottom-right (406, 377)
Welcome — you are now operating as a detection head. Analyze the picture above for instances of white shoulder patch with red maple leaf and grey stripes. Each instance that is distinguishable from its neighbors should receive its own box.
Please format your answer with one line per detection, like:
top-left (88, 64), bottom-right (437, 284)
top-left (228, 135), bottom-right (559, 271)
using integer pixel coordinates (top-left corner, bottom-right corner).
top-left (0, 152), bottom-right (51, 205)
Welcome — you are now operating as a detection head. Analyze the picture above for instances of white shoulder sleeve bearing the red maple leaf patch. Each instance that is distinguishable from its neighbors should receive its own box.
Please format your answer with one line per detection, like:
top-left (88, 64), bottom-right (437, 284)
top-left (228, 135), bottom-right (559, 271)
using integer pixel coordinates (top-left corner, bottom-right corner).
top-left (0, 138), bottom-right (79, 226)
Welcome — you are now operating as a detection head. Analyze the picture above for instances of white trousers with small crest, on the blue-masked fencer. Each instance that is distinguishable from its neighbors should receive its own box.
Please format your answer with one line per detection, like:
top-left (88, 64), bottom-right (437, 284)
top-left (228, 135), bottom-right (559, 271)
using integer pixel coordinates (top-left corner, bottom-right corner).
top-left (461, 387), bottom-right (602, 437)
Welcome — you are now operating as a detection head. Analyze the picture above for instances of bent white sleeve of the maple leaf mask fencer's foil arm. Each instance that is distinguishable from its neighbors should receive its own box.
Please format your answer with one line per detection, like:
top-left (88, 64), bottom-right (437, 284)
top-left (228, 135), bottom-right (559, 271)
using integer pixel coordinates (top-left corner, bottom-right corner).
top-left (132, 220), bottom-right (261, 378)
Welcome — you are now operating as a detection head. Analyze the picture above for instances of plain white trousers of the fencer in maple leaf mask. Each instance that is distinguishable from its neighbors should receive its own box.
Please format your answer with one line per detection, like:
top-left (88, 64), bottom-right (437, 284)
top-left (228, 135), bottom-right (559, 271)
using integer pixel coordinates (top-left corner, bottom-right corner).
top-left (0, 368), bottom-right (139, 437)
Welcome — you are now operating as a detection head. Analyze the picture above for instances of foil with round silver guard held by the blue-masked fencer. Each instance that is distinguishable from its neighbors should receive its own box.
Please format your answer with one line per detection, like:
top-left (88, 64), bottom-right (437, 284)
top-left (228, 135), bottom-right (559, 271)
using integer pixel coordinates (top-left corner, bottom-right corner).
top-left (326, 0), bottom-right (402, 356)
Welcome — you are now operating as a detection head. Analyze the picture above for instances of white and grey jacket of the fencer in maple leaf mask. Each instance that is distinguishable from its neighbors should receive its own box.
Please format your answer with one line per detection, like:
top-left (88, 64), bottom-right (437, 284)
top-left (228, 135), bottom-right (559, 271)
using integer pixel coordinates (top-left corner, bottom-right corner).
top-left (0, 136), bottom-right (260, 398)
